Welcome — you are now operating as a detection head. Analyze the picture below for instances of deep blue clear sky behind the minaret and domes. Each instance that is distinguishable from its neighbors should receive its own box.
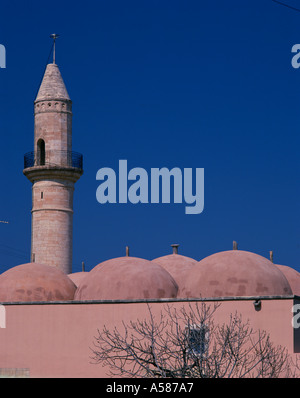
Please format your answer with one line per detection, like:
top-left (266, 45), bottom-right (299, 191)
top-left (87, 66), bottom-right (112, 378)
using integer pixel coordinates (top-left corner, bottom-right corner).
top-left (0, 0), bottom-right (300, 272)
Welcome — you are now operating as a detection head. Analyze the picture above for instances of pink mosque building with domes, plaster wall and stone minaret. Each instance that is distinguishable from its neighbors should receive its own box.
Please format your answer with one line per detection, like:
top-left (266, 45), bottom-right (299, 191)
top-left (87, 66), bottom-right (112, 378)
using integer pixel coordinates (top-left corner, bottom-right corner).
top-left (0, 48), bottom-right (300, 377)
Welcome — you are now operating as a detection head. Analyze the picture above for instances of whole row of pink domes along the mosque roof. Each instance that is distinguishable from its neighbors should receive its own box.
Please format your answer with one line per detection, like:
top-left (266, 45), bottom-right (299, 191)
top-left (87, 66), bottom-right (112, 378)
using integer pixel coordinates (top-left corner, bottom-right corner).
top-left (0, 245), bottom-right (300, 302)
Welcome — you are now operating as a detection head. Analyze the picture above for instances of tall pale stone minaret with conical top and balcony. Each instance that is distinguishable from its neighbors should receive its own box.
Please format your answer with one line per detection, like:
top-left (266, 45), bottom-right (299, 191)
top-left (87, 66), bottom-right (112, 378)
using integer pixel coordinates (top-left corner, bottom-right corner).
top-left (23, 39), bottom-right (83, 274)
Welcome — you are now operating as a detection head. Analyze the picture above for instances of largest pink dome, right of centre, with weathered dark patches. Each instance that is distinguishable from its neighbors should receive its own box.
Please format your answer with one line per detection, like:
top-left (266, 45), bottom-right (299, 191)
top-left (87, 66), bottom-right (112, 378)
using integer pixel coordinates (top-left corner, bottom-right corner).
top-left (182, 250), bottom-right (292, 298)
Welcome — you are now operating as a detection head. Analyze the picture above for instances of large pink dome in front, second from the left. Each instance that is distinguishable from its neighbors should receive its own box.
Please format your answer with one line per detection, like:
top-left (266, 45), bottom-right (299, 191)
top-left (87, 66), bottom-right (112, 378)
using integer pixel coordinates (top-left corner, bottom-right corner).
top-left (75, 256), bottom-right (178, 300)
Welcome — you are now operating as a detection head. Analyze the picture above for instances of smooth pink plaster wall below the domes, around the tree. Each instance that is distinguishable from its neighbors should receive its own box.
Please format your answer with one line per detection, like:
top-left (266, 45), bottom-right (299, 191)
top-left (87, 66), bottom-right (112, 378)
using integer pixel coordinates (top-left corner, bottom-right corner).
top-left (0, 299), bottom-right (293, 377)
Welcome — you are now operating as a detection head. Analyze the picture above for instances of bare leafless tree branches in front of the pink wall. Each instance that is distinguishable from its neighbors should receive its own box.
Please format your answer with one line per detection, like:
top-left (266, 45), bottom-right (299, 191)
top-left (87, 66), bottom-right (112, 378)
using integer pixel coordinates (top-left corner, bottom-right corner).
top-left (92, 302), bottom-right (295, 378)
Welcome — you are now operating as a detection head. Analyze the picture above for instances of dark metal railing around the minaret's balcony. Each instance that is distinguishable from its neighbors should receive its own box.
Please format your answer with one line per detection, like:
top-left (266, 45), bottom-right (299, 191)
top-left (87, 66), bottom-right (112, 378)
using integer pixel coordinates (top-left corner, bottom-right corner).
top-left (24, 150), bottom-right (83, 170)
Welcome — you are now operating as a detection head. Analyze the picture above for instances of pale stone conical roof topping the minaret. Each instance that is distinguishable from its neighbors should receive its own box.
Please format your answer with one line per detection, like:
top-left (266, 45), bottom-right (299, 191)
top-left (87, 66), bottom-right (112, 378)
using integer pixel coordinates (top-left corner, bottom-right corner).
top-left (35, 63), bottom-right (70, 101)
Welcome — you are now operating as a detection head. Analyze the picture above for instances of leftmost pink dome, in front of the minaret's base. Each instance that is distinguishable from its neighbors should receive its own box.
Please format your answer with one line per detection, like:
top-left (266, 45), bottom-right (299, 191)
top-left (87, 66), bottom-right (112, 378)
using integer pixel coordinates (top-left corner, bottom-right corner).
top-left (0, 263), bottom-right (76, 302)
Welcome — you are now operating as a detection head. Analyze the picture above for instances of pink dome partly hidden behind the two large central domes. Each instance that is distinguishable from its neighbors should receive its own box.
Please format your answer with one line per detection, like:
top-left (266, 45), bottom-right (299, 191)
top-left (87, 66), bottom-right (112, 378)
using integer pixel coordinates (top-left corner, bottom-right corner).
top-left (152, 253), bottom-right (198, 297)
